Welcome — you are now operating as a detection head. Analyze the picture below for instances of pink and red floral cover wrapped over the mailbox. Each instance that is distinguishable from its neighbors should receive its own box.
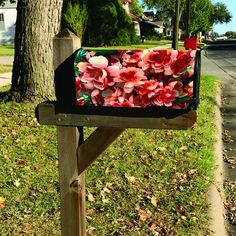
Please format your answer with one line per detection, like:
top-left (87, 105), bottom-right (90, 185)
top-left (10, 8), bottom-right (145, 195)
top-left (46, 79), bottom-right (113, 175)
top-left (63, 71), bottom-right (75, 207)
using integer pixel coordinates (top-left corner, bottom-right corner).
top-left (75, 49), bottom-right (199, 116)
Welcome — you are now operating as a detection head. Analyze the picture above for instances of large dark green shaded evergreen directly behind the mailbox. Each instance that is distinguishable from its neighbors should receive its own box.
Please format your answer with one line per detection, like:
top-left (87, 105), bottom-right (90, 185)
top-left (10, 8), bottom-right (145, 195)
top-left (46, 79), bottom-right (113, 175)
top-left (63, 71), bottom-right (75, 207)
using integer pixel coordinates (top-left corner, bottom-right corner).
top-left (83, 0), bottom-right (136, 46)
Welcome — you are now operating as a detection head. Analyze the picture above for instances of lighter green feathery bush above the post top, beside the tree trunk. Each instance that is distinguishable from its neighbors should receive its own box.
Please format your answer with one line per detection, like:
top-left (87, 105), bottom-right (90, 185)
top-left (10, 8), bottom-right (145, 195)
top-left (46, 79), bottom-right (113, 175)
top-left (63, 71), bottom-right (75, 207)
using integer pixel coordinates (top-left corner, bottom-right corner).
top-left (62, 0), bottom-right (88, 39)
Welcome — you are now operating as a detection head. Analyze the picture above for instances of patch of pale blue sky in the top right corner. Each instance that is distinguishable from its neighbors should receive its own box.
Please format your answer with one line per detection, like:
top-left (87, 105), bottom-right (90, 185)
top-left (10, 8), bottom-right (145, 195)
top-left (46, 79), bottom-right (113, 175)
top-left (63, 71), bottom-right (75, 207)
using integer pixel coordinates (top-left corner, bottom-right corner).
top-left (211, 0), bottom-right (236, 34)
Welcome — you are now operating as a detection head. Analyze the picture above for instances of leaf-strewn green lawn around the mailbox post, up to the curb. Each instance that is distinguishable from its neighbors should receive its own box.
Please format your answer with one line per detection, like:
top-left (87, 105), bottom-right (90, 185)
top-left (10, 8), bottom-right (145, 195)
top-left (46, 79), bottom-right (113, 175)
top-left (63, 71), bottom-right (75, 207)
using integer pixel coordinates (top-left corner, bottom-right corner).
top-left (0, 76), bottom-right (217, 236)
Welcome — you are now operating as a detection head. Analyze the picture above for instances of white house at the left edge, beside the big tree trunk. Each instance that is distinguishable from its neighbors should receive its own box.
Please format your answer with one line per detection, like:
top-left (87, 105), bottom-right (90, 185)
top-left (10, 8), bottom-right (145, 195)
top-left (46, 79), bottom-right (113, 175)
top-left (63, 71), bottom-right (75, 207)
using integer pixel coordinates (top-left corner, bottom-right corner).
top-left (0, 1), bottom-right (17, 44)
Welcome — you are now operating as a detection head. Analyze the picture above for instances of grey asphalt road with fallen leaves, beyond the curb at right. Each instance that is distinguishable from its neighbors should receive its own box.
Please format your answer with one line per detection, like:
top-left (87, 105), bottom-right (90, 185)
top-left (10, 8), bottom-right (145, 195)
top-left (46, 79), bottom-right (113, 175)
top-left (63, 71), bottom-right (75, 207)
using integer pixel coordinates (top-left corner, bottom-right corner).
top-left (206, 40), bottom-right (236, 236)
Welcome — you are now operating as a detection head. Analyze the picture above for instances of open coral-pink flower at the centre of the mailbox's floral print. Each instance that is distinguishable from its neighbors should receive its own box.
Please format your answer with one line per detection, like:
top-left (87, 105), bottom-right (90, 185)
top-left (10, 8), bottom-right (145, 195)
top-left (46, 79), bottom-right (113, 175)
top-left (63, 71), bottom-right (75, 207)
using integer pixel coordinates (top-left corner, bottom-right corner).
top-left (114, 67), bottom-right (147, 93)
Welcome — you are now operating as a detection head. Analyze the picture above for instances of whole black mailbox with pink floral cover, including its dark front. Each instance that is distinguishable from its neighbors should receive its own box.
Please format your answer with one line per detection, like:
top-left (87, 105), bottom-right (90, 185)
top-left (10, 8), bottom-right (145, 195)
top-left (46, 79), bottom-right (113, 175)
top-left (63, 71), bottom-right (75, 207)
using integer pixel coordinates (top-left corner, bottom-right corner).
top-left (55, 48), bottom-right (200, 117)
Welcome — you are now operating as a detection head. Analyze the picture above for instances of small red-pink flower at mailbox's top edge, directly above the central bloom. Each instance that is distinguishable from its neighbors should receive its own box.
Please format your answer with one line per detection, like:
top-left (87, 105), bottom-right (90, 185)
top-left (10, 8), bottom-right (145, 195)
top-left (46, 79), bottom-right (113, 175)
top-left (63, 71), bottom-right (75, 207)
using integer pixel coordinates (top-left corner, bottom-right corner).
top-left (122, 50), bottom-right (143, 67)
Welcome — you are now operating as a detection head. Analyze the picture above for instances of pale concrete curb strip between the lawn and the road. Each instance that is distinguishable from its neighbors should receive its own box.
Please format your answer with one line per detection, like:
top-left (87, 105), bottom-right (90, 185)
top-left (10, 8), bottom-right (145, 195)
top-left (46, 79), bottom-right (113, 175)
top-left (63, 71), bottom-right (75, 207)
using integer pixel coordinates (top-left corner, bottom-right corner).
top-left (208, 80), bottom-right (228, 236)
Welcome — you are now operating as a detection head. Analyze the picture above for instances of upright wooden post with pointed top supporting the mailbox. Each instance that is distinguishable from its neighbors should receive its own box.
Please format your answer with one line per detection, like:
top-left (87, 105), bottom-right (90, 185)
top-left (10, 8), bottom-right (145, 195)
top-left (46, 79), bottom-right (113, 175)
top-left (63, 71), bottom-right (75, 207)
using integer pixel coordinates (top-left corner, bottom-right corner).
top-left (53, 29), bottom-right (86, 236)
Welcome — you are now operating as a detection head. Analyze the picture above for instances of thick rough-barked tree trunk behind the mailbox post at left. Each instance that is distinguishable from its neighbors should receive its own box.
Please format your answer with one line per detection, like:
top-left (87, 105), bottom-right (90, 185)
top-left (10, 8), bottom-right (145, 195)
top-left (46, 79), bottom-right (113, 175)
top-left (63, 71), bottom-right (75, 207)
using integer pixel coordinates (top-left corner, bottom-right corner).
top-left (11, 0), bottom-right (63, 102)
